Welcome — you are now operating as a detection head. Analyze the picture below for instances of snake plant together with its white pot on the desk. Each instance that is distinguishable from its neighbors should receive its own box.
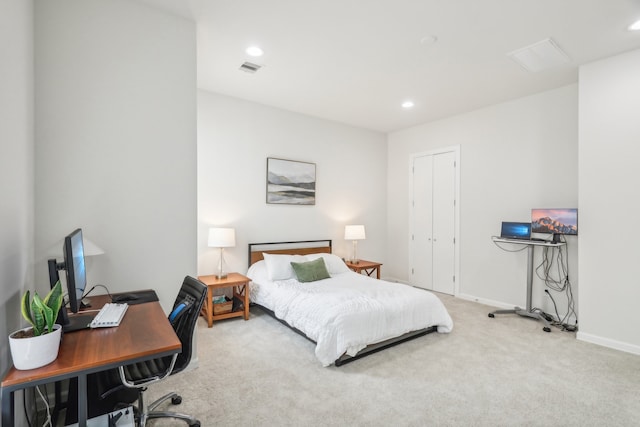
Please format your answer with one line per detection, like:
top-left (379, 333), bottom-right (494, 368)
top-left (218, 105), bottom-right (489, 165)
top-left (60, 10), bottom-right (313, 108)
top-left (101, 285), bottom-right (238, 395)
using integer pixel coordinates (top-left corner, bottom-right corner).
top-left (9, 281), bottom-right (62, 370)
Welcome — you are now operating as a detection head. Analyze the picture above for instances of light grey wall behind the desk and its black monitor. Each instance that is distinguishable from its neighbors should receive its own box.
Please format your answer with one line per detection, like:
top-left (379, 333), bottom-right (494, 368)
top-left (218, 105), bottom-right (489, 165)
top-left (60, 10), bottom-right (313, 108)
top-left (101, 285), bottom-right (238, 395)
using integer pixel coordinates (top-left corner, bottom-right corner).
top-left (35, 0), bottom-right (197, 310)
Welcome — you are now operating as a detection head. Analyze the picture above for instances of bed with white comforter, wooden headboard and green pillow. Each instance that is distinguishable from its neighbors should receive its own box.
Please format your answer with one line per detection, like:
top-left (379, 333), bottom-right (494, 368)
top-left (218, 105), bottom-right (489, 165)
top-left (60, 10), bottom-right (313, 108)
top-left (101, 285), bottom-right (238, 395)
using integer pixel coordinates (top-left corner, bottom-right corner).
top-left (247, 240), bottom-right (453, 366)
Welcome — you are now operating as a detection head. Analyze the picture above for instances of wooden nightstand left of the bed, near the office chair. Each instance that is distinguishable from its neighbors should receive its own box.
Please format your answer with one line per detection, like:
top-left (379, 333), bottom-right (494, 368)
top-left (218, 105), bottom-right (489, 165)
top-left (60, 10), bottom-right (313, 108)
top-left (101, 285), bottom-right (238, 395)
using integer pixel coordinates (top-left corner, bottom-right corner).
top-left (198, 273), bottom-right (251, 327)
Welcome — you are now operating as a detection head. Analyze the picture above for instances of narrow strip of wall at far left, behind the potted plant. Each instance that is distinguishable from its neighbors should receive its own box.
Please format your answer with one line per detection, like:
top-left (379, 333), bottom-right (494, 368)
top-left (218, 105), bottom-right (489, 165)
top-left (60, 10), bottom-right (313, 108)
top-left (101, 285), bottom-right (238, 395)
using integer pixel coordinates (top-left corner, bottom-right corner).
top-left (0, 0), bottom-right (34, 425)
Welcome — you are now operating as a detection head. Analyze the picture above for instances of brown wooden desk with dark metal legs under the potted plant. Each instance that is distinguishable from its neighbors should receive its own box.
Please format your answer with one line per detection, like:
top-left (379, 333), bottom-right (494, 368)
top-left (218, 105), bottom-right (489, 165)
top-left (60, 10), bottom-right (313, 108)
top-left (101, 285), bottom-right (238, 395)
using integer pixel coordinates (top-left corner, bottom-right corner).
top-left (0, 296), bottom-right (182, 427)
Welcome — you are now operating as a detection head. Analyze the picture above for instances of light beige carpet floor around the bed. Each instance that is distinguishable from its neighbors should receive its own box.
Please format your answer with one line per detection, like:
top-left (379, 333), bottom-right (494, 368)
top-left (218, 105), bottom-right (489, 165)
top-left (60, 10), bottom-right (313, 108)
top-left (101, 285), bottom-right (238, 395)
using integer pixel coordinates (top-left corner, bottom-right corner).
top-left (148, 295), bottom-right (640, 426)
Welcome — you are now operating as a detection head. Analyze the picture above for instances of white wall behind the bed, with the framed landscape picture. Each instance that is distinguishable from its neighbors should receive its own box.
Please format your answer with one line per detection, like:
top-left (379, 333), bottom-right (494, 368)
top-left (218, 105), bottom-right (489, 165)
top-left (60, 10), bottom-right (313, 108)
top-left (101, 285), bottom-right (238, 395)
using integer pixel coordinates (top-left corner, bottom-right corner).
top-left (198, 91), bottom-right (386, 274)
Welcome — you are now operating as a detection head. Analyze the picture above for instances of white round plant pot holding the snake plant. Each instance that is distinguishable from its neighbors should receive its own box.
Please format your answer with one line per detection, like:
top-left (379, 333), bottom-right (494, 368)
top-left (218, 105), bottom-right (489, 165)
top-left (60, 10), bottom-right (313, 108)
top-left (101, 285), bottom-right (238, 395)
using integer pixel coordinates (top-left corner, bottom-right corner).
top-left (9, 325), bottom-right (62, 370)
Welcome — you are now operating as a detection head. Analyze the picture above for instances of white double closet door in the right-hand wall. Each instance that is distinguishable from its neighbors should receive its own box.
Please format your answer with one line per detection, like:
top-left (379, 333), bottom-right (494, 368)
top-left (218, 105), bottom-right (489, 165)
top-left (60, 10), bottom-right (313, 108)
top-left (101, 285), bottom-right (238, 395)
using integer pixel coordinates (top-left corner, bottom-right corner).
top-left (410, 152), bottom-right (456, 295)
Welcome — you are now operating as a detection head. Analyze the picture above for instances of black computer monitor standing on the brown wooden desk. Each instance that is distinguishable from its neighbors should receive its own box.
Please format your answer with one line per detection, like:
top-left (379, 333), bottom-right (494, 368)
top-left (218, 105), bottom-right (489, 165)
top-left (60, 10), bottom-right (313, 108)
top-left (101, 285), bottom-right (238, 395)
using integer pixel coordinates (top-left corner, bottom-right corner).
top-left (49, 228), bottom-right (95, 332)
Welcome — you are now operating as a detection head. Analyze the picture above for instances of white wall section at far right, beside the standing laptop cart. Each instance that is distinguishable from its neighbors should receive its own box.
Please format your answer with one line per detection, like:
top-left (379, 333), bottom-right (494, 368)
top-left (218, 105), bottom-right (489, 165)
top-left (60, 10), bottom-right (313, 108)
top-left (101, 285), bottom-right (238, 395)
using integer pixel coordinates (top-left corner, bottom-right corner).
top-left (578, 50), bottom-right (640, 354)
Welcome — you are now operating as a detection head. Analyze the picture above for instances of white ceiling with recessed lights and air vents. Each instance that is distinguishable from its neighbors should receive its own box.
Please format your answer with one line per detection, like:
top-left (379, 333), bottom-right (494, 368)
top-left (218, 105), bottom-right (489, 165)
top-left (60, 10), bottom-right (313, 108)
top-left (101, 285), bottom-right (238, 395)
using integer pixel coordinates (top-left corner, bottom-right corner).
top-left (140, 0), bottom-right (640, 132)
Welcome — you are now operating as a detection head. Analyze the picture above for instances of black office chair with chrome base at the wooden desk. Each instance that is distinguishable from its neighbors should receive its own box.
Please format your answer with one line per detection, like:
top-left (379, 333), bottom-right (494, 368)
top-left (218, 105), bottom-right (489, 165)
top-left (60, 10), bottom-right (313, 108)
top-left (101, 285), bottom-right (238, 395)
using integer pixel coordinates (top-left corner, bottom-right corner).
top-left (102, 276), bottom-right (207, 427)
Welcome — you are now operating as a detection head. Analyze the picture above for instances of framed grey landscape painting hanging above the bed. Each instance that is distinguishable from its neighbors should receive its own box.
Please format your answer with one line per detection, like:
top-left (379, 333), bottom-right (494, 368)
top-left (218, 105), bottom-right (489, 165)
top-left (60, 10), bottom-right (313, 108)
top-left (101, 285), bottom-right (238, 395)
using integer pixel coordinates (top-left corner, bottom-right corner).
top-left (267, 157), bottom-right (316, 205)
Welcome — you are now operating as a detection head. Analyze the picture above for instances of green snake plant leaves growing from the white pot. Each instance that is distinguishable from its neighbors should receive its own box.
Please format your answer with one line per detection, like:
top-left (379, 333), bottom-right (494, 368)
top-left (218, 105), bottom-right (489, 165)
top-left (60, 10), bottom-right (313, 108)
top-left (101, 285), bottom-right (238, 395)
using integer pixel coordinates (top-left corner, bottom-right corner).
top-left (21, 280), bottom-right (62, 336)
